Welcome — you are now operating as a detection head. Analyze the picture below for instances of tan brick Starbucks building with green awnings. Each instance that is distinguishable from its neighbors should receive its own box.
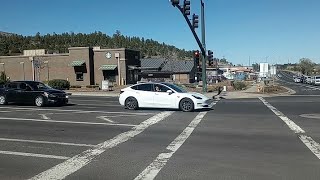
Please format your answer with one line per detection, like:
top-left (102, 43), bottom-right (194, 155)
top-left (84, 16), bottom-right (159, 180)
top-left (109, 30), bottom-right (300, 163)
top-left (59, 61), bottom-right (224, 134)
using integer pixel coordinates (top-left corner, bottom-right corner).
top-left (0, 47), bottom-right (141, 86)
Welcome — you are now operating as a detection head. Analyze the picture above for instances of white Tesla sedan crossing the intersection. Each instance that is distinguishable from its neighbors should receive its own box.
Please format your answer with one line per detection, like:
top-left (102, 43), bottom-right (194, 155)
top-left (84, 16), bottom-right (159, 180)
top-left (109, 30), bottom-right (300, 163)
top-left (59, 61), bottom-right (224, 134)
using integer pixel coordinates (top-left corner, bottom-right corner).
top-left (119, 82), bottom-right (213, 112)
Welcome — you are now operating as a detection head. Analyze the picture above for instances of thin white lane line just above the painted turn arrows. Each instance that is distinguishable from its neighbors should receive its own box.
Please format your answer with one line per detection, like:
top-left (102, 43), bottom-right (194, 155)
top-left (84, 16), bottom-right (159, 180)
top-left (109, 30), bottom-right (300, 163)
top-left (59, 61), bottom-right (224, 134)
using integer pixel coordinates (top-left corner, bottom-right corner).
top-left (0, 106), bottom-right (154, 115)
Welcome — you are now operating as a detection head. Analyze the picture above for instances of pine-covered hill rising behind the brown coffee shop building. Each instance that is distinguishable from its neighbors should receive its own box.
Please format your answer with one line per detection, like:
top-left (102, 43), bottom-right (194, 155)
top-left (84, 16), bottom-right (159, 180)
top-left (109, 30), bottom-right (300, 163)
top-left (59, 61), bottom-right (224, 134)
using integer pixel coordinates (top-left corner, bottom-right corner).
top-left (0, 31), bottom-right (193, 60)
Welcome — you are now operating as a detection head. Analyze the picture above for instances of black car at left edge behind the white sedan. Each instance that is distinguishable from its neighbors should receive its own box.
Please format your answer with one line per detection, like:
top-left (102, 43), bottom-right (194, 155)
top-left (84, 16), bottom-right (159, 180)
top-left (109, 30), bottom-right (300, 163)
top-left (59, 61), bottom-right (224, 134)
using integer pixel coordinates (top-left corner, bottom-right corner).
top-left (0, 81), bottom-right (69, 107)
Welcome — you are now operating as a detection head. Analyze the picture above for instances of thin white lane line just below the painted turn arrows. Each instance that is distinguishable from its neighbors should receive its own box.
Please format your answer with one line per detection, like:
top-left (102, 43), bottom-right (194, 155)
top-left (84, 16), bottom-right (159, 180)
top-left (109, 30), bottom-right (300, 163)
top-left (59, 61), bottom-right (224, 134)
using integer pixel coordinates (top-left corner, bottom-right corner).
top-left (0, 117), bottom-right (136, 127)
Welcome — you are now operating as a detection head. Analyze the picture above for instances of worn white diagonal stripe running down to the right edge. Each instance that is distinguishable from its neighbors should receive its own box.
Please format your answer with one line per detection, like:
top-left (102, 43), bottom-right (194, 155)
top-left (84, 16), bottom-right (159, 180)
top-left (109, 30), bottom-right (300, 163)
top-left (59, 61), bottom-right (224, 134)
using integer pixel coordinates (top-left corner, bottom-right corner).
top-left (259, 97), bottom-right (320, 159)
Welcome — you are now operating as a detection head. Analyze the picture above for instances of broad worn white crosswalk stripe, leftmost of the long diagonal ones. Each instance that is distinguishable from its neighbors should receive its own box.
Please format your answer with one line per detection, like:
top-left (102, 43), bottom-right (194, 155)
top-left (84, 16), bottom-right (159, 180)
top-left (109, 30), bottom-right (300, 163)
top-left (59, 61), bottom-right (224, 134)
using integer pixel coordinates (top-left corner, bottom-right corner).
top-left (31, 111), bottom-right (173, 180)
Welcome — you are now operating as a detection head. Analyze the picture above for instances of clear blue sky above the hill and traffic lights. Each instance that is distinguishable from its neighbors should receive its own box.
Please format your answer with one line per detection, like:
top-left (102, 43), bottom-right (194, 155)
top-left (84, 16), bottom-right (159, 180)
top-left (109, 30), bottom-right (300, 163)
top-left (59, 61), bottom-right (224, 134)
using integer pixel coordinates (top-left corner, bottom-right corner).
top-left (0, 0), bottom-right (320, 65)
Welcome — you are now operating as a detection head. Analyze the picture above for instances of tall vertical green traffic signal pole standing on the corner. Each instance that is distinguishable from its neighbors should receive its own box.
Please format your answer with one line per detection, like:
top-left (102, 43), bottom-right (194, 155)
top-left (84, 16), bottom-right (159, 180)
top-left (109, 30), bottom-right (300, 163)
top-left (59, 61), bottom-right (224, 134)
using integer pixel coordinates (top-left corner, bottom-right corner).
top-left (201, 0), bottom-right (207, 92)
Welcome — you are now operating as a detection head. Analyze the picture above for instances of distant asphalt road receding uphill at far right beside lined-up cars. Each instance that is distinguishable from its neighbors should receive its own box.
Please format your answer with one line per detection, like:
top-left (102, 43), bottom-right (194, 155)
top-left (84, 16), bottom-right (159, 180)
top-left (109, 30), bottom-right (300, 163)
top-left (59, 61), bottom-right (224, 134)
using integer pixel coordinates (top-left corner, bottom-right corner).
top-left (277, 71), bottom-right (320, 95)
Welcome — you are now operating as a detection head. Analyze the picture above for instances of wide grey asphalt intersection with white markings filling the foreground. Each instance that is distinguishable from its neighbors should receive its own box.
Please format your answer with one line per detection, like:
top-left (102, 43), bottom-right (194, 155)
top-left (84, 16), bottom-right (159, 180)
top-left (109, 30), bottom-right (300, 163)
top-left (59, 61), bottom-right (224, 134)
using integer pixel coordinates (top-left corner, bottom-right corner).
top-left (0, 88), bottom-right (320, 180)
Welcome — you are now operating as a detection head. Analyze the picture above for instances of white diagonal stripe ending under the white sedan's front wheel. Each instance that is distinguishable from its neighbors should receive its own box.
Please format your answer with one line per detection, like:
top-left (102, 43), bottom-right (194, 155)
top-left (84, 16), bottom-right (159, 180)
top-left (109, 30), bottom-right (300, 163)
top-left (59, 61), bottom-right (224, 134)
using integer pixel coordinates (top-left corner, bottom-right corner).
top-left (135, 112), bottom-right (207, 180)
